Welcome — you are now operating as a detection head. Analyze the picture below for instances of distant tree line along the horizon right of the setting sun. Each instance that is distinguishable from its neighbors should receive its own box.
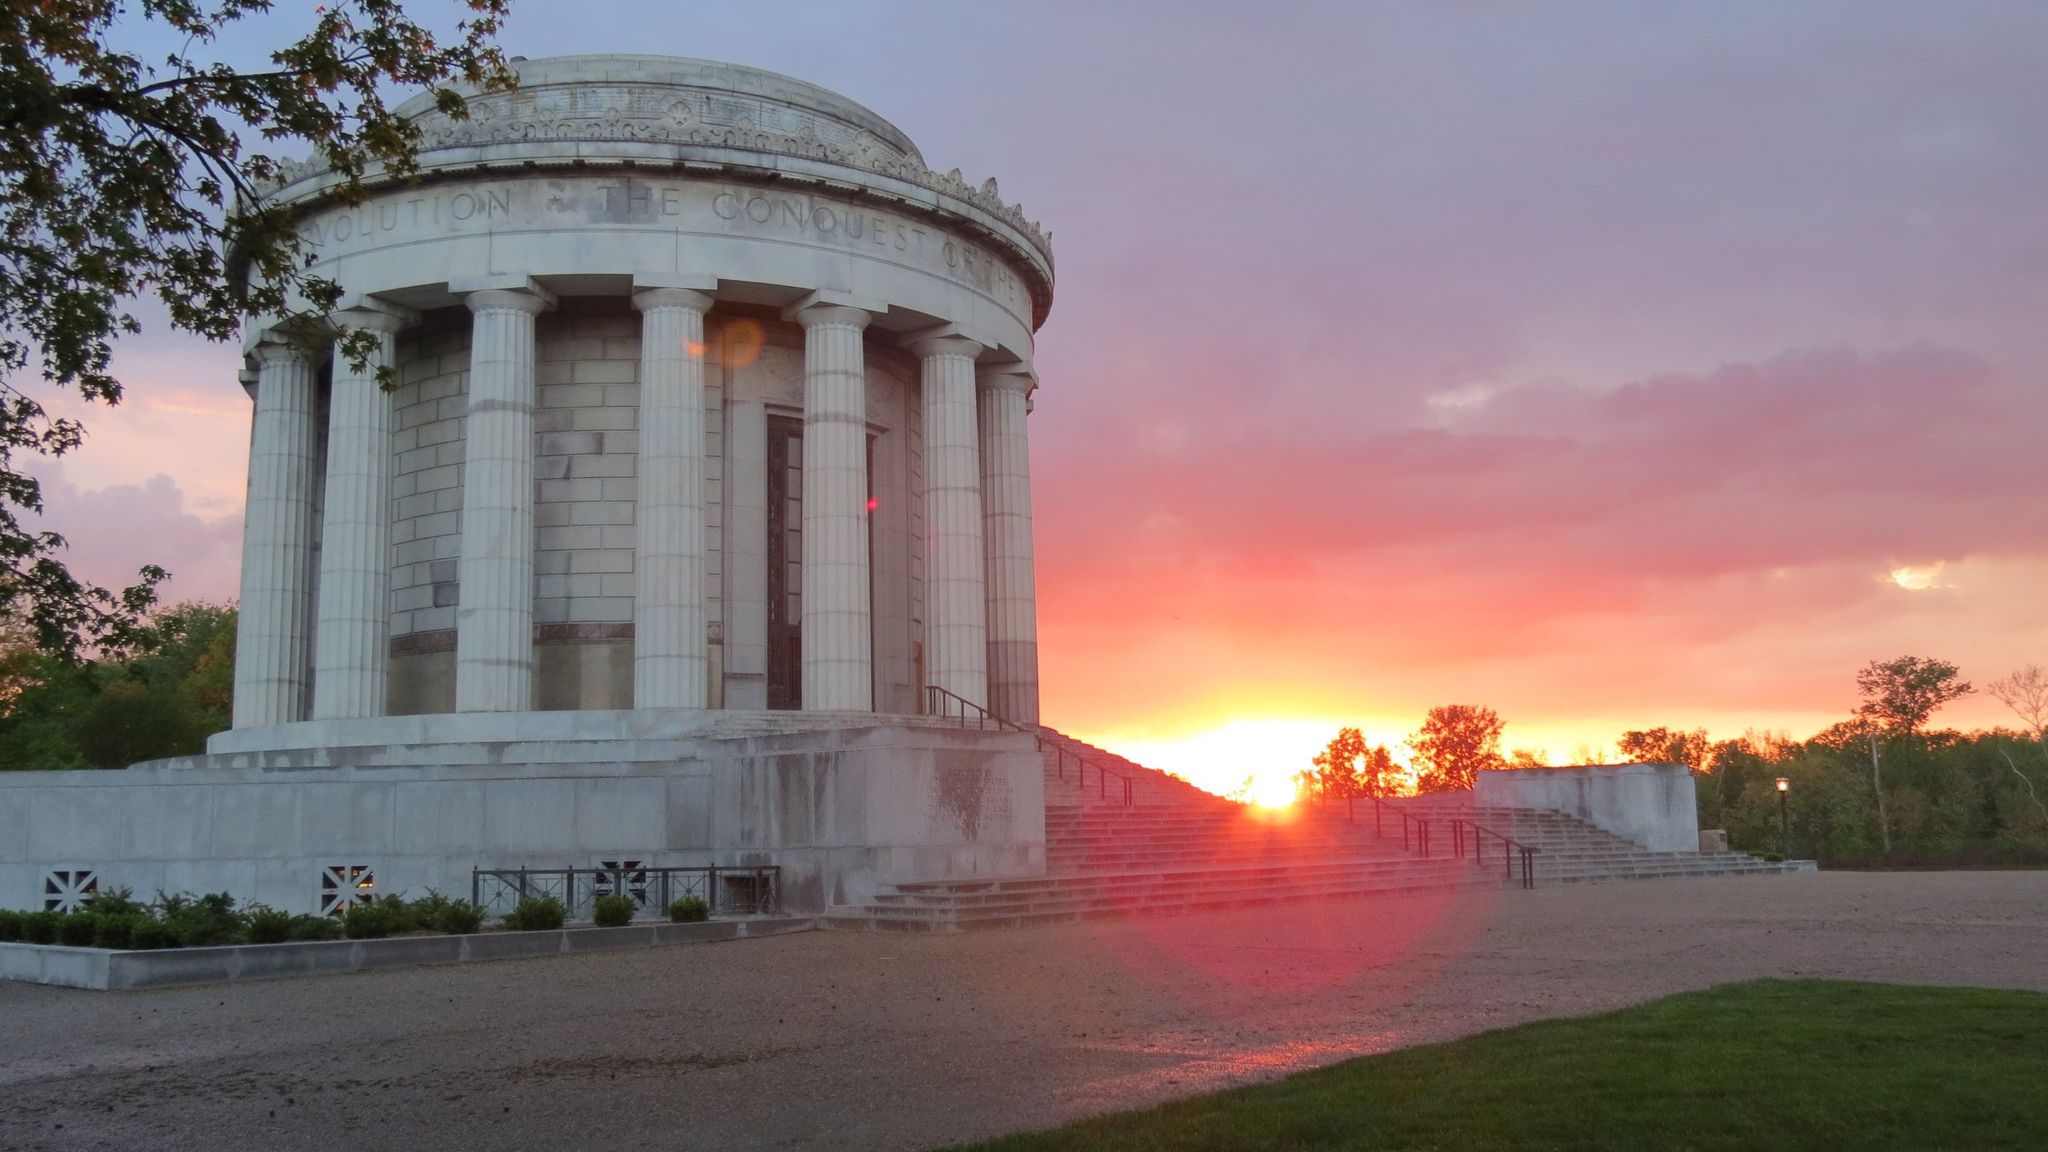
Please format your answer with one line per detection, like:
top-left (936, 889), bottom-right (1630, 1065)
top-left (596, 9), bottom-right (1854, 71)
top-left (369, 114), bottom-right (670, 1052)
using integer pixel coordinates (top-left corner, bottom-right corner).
top-left (1294, 656), bottom-right (2048, 865)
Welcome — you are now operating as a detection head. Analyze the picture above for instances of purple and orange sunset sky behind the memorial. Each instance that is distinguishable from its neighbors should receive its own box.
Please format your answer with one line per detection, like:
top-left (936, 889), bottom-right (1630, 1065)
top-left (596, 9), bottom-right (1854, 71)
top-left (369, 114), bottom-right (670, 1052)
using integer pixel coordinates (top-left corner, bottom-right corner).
top-left (43, 0), bottom-right (2048, 787)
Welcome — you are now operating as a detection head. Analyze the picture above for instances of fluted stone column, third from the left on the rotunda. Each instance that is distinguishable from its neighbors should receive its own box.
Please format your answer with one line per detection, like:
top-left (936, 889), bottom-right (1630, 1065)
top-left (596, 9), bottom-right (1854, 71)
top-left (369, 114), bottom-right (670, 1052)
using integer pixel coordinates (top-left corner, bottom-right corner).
top-left (455, 289), bottom-right (547, 711)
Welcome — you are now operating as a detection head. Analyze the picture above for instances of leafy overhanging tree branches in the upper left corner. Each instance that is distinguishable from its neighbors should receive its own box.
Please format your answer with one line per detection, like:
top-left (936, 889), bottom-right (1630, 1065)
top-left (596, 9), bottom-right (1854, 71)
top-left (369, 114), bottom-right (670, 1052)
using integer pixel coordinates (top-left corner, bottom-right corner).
top-left (0, 0), bottom-right (512, 656)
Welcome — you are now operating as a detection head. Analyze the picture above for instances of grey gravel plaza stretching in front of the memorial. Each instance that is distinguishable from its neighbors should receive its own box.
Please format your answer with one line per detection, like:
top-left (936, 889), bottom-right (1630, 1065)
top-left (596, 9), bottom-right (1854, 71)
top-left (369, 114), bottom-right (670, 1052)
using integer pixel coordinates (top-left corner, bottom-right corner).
top-left (0, 871), bottom-right (2048, 1150)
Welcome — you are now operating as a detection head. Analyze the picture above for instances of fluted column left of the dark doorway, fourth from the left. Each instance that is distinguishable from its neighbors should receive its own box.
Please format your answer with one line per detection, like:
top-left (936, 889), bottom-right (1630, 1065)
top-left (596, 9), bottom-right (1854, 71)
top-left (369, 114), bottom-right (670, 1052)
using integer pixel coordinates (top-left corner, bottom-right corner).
top-left (633, 289), bottom-right (711, 707)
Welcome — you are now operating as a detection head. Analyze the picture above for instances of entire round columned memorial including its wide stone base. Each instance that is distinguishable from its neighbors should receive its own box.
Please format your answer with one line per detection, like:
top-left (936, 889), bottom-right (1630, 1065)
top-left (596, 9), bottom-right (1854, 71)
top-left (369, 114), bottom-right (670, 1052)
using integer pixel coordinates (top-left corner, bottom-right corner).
top-left (0, 55), bottom-right (1053, 910)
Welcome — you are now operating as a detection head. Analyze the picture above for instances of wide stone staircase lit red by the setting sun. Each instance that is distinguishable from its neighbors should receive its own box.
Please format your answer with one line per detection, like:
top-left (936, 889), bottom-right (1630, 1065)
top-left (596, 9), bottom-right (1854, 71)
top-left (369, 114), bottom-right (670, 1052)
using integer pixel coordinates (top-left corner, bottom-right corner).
top-left (821, 730), bottom-right (1812, 933)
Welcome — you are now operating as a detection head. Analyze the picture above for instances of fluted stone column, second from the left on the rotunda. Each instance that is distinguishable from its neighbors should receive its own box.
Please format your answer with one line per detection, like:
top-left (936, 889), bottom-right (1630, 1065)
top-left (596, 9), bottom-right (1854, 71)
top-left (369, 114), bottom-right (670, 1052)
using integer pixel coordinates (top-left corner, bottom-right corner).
top-left (313, 310), bottom-right (403, 719)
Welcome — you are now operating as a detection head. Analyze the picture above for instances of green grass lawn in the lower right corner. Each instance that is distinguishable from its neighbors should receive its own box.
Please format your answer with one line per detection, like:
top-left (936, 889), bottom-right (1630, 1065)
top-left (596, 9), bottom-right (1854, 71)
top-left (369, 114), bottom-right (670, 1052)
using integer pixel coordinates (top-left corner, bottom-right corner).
top-left (954, 975), bottom-right (2048, 1152)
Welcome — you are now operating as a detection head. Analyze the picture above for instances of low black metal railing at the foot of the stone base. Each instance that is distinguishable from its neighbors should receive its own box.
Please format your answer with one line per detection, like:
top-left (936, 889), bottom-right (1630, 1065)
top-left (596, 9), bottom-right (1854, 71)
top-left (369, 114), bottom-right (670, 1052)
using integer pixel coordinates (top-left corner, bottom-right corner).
top-left (469, 861), bottom-right (782, 920)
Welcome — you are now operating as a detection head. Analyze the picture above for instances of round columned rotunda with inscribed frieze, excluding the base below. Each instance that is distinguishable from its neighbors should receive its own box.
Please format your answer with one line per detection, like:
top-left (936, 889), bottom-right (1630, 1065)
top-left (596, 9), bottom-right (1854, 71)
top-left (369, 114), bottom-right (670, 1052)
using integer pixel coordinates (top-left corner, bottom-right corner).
top-left (233, 55), bottom-right (1053, 730)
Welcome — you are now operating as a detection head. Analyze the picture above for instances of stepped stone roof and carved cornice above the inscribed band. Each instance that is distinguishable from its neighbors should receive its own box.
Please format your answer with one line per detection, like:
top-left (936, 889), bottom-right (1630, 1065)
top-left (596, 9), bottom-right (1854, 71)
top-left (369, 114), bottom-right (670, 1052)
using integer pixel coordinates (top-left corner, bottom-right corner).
top-left (260, 55), bottom-right (1053, 328)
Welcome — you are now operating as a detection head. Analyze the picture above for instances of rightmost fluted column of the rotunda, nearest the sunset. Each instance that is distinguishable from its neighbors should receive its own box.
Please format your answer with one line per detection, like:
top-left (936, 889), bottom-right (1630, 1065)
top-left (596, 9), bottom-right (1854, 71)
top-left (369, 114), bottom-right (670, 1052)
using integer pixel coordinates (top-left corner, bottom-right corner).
top-left (981, 369), bottom-right (1038, 724)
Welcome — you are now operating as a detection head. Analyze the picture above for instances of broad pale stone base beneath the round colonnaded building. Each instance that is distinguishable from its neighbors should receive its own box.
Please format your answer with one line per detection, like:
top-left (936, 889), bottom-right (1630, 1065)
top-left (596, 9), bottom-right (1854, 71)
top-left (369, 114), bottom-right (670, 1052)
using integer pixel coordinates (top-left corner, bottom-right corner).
top-left (0, 711), bottom-right (1044, 912)
